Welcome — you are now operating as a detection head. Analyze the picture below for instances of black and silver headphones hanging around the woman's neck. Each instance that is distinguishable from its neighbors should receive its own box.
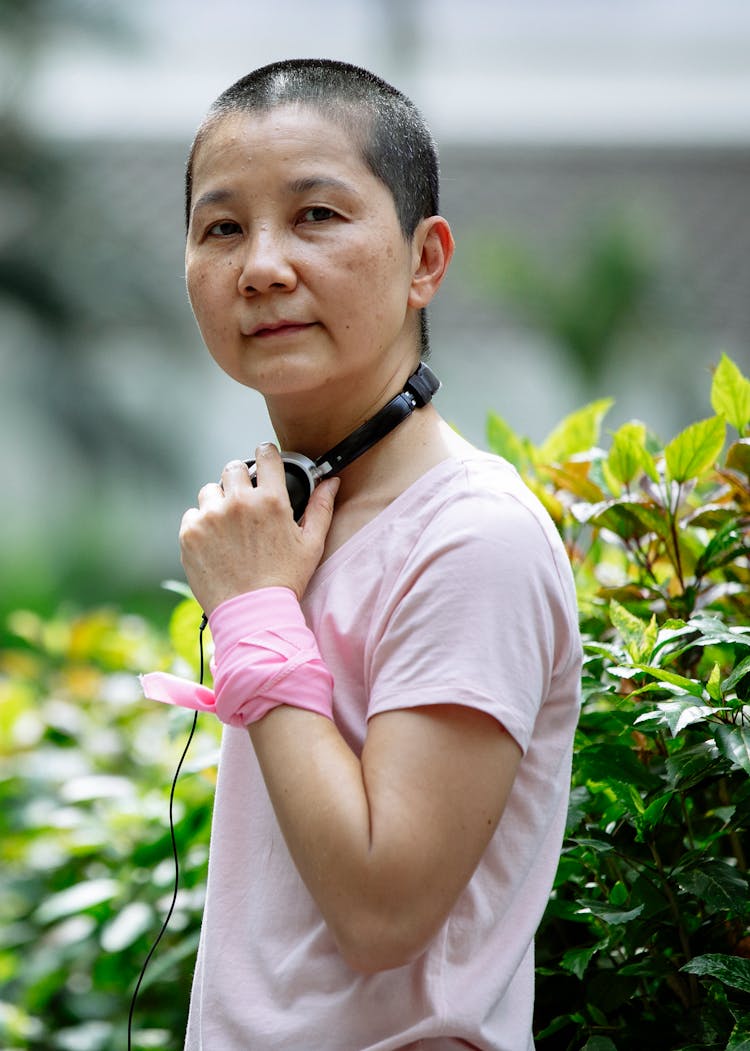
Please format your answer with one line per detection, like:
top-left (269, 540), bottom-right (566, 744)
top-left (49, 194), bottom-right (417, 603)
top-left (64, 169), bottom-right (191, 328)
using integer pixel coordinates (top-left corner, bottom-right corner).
top-left (245, 363), bottom-right (440, 521)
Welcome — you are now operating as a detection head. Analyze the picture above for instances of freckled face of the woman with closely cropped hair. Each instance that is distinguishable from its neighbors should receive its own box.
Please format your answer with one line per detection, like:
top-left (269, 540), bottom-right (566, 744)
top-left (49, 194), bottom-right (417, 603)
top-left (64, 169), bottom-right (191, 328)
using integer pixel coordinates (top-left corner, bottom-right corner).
top-left (186, 105), bottom-right (424, 409)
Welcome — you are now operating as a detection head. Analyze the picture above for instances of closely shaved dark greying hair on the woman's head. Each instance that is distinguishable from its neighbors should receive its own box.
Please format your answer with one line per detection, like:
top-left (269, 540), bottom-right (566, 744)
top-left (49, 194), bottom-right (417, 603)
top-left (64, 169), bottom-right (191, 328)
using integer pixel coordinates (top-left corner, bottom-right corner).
top-left (185, 59), bottom-right (440, 356)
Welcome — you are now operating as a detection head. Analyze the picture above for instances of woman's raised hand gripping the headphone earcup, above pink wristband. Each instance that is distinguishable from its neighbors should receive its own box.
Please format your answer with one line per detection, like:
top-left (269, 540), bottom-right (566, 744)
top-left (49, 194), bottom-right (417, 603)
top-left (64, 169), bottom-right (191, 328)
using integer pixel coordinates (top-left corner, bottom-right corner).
top-left (180, 445), bottom-right (338, 615)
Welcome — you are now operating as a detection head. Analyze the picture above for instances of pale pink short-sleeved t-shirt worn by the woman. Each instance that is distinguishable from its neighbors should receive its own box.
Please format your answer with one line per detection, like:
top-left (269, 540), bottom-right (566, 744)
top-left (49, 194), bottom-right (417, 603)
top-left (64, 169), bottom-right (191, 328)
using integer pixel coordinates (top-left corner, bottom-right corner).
top-left (186, 453), bottom-right (581, 1051)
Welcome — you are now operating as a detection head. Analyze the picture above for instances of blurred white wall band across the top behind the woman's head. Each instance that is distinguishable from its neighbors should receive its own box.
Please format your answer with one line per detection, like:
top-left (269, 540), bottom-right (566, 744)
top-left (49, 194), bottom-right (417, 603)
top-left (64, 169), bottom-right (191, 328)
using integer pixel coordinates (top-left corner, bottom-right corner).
top-left (20, 0), bottom-right (750, 144)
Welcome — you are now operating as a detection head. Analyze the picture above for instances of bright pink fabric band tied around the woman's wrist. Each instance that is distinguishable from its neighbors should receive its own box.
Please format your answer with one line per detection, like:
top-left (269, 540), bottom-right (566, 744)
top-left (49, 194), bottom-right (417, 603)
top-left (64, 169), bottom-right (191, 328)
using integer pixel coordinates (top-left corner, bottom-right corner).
top-left (141, 588), bottom-right (333, 726)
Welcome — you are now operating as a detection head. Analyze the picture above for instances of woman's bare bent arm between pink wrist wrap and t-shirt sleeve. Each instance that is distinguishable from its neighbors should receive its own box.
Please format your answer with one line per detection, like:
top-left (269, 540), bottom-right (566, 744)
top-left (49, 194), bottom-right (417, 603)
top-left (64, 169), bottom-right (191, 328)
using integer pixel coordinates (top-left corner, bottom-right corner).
top-left (249, 703), bottom-right (521, 972)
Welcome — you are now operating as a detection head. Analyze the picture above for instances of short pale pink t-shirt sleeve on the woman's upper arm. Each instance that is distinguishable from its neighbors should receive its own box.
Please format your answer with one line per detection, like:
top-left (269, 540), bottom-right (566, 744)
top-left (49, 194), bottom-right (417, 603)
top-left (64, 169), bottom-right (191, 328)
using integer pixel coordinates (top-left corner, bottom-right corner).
top-left (368, 493), bottom-right (569, 751)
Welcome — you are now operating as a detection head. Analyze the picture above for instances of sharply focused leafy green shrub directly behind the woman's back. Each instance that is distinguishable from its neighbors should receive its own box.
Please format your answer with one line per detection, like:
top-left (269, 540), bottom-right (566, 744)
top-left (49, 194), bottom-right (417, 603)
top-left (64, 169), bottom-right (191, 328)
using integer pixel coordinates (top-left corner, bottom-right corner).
top-left (481, 356), bottom-right (750, 1051)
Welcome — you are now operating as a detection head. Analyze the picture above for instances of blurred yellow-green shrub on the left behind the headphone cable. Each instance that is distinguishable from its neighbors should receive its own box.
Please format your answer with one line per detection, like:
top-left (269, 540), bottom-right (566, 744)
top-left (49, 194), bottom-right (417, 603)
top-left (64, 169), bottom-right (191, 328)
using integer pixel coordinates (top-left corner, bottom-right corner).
top-left (0, 602), bottom-right (217, 1051)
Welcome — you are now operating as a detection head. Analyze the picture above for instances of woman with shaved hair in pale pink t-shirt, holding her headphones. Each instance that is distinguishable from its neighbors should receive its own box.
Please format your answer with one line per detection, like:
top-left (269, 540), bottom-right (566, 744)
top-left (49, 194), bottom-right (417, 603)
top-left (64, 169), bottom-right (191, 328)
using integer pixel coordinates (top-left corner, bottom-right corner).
top-left (146, 60), bottom-right (580, 1051)
